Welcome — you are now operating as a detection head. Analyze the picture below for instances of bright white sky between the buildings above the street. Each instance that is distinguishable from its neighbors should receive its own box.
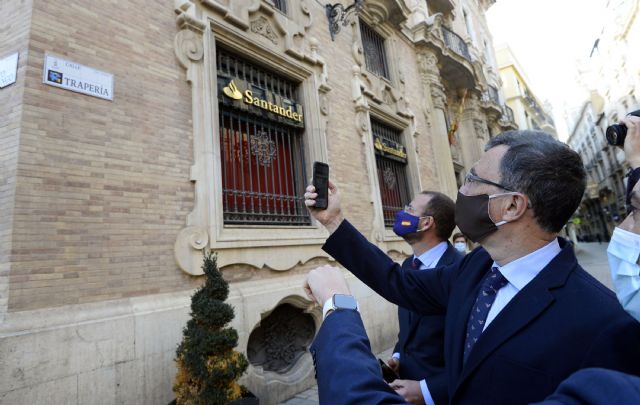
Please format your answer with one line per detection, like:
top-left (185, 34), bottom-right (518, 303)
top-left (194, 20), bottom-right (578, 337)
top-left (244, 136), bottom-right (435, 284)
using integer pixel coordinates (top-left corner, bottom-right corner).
top-left (487, 0), bottom-right (606, 141)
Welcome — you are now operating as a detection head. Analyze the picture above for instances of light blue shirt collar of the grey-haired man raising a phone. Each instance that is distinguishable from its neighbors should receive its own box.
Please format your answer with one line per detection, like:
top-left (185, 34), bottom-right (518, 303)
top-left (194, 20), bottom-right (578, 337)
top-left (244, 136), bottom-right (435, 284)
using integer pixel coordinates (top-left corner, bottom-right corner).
top-left (493, 238), bottom-right (562, 291)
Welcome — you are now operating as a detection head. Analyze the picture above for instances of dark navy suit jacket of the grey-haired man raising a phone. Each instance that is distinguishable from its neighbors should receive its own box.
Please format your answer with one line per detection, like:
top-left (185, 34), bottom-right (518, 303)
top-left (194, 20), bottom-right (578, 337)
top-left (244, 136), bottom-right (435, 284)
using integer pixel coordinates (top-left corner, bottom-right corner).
top-left (318, 221), bottom-right (640, 405)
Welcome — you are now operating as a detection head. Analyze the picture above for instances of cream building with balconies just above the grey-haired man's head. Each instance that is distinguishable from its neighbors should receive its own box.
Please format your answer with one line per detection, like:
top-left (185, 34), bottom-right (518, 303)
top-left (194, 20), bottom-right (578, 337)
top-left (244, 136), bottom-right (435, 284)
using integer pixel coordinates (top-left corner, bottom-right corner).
top-left (496, 45), bottom-right (558, 139)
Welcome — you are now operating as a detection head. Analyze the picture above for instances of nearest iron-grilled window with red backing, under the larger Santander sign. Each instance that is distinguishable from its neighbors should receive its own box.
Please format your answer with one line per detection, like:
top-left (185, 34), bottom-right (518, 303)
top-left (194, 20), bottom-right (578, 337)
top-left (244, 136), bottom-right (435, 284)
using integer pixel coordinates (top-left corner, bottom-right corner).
top-left (216, 48), bottom-right (311, 225)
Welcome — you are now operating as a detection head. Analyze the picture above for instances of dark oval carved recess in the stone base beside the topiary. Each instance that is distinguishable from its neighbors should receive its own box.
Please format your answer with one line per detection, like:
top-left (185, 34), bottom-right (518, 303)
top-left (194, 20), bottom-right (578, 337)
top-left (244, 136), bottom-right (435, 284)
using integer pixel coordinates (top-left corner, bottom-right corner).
top-left (247, 304), bottom-right (316, 373)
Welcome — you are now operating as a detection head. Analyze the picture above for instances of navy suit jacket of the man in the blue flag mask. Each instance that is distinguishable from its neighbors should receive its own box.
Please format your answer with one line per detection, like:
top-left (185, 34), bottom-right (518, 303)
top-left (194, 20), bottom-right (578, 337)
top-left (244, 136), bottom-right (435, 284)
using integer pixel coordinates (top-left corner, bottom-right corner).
top-left (394, 242), bottom-right (464, 404)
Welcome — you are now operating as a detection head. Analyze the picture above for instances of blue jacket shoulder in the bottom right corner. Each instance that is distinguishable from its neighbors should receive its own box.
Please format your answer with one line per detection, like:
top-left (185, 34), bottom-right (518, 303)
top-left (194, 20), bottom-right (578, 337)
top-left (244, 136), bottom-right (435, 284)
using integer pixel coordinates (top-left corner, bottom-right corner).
top-left (536, 368), bottom-right (640, 405)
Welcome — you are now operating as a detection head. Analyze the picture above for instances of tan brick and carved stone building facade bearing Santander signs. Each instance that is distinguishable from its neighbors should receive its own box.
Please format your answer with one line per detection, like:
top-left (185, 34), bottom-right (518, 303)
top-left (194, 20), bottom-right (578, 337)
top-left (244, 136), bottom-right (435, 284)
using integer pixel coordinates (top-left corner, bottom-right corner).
top-left (0, 0), bottom-right (515, 404)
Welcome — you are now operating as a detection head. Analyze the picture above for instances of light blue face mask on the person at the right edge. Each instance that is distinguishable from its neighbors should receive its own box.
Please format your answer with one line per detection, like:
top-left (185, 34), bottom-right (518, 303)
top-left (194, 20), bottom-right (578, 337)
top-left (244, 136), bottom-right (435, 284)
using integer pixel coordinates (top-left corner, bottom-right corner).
top-left (607, 228), bottom-right (640, 321)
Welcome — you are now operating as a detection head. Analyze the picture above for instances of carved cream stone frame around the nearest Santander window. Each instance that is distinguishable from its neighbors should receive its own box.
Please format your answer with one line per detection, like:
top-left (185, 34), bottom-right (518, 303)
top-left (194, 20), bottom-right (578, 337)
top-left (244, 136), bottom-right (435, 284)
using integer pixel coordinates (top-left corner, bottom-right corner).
top-left (174, 0), bottom-right (331, 275)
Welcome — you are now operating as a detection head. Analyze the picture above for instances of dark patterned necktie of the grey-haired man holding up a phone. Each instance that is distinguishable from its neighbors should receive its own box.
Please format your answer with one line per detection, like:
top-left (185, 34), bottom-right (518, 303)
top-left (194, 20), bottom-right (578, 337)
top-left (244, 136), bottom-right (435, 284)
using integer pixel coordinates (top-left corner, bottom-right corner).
top-left (464, 267), bottom-right (508, 363)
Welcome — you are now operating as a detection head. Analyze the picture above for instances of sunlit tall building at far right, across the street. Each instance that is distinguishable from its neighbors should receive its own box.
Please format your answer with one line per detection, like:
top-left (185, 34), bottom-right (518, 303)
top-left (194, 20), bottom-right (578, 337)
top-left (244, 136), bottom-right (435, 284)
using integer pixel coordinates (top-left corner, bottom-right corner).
top-left (567, 0), bottom-right (640, 240)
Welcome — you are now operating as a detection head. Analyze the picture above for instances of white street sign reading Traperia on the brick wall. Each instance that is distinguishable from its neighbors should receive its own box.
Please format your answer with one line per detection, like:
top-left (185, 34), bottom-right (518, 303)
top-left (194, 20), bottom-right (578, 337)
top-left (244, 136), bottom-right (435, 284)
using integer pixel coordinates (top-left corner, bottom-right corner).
top-left (42, 54), bottom-right (113, 100)
